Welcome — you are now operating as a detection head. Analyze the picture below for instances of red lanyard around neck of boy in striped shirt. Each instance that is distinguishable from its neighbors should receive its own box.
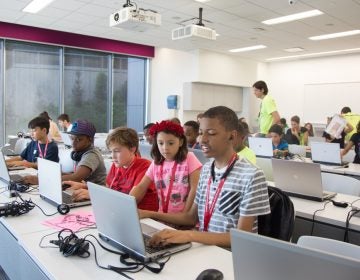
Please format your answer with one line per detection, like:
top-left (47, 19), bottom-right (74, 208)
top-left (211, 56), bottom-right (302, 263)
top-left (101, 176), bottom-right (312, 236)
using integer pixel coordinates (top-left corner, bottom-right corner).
top-left (203, 154), bottom-right (238, 231)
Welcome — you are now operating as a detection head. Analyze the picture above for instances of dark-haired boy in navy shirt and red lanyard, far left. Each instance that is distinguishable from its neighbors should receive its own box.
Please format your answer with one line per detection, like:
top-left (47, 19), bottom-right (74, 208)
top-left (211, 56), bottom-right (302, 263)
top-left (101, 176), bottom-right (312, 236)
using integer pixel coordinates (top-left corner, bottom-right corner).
top-left (6, 117), bottom-right (59, 168)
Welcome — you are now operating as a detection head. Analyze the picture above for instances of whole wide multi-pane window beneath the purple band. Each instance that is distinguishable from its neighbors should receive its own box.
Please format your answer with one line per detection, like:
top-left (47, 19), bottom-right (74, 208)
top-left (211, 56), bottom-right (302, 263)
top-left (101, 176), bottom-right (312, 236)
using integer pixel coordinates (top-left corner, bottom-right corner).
top-left (0, 40), bottom-right (147, 145)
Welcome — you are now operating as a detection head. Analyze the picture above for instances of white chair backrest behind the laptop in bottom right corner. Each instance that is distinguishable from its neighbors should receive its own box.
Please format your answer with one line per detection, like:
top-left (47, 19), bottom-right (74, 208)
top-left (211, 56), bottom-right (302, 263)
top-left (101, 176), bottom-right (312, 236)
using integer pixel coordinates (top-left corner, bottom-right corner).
top-left (297, 235), bottom-right (360, 260)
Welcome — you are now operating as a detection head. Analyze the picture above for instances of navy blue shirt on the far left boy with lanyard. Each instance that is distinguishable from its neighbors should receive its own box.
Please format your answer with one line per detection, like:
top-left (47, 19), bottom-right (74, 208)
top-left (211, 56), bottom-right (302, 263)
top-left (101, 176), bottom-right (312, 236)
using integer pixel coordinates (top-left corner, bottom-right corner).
top-left (20, 140), bottom-right (59, 162)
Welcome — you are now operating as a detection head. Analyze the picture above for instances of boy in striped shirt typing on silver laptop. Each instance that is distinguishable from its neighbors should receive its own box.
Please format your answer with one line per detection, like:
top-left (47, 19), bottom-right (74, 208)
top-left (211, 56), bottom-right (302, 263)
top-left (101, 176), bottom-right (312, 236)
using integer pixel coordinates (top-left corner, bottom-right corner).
top-left (140, 106), bottom-right (270, 247)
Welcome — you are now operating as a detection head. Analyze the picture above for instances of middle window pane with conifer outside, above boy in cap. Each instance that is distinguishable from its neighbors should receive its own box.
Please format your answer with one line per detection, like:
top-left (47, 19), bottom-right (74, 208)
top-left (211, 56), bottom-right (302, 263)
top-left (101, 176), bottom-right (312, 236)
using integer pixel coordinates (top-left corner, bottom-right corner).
top-left (64, 49), bottom-right (109, 132)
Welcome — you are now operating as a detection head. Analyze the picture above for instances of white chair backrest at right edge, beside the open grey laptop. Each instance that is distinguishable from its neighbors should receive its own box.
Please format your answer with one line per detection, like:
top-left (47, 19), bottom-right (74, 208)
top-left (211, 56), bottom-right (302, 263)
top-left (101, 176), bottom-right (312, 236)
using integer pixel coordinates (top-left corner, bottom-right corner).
top-left (321, 172), bottom-right (360, 196)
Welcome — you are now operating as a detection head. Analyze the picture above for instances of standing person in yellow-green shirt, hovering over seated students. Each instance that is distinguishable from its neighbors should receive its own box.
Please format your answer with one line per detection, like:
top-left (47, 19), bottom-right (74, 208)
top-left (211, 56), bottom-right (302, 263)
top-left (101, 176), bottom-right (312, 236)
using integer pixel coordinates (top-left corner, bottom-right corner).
top-left (253, 81), bottom-right (280, 136)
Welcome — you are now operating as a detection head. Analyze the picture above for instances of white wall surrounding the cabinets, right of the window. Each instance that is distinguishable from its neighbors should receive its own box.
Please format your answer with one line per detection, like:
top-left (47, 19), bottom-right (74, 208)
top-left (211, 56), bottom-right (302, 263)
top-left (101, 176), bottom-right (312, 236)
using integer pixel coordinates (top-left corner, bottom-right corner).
top-left (148, 48), bottom-right (259, 122)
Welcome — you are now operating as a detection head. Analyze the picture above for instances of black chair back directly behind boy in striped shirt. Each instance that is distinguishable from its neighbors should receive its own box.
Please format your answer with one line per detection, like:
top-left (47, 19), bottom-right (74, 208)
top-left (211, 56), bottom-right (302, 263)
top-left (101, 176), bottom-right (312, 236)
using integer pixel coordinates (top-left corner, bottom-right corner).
top-left (258, 187), bottom-right (295, 241)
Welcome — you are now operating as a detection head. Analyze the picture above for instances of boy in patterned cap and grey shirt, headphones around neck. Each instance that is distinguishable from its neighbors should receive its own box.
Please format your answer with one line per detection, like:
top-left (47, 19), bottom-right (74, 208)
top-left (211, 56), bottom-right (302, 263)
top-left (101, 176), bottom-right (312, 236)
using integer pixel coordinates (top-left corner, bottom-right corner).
top-left (24, 120), bottom-right (106, 185)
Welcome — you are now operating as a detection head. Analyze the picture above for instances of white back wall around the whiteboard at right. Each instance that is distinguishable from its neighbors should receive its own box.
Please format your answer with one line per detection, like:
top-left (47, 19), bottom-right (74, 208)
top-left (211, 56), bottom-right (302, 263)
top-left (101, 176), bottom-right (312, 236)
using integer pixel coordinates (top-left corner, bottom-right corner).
top-left (266, 54), bottom-right (360, 123)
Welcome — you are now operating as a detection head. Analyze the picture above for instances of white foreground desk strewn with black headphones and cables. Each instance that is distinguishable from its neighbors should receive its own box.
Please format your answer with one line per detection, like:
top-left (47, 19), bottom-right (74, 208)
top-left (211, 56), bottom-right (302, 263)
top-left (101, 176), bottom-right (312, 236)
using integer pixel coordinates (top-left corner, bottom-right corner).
top-left (0, 190), bottom-right (234, 280)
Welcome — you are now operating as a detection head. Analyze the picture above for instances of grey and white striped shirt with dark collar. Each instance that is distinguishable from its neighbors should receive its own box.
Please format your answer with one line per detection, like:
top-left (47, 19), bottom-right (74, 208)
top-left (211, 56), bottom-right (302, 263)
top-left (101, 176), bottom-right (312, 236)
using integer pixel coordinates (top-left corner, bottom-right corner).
top-left (195, 159), bottom-right (270, 232)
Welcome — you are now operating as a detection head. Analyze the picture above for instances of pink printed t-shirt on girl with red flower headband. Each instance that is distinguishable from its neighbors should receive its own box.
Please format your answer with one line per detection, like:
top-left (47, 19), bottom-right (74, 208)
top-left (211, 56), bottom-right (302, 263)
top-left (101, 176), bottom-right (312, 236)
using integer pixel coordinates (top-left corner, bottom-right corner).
top-left (145, 152), bottom-right (202, 213)
